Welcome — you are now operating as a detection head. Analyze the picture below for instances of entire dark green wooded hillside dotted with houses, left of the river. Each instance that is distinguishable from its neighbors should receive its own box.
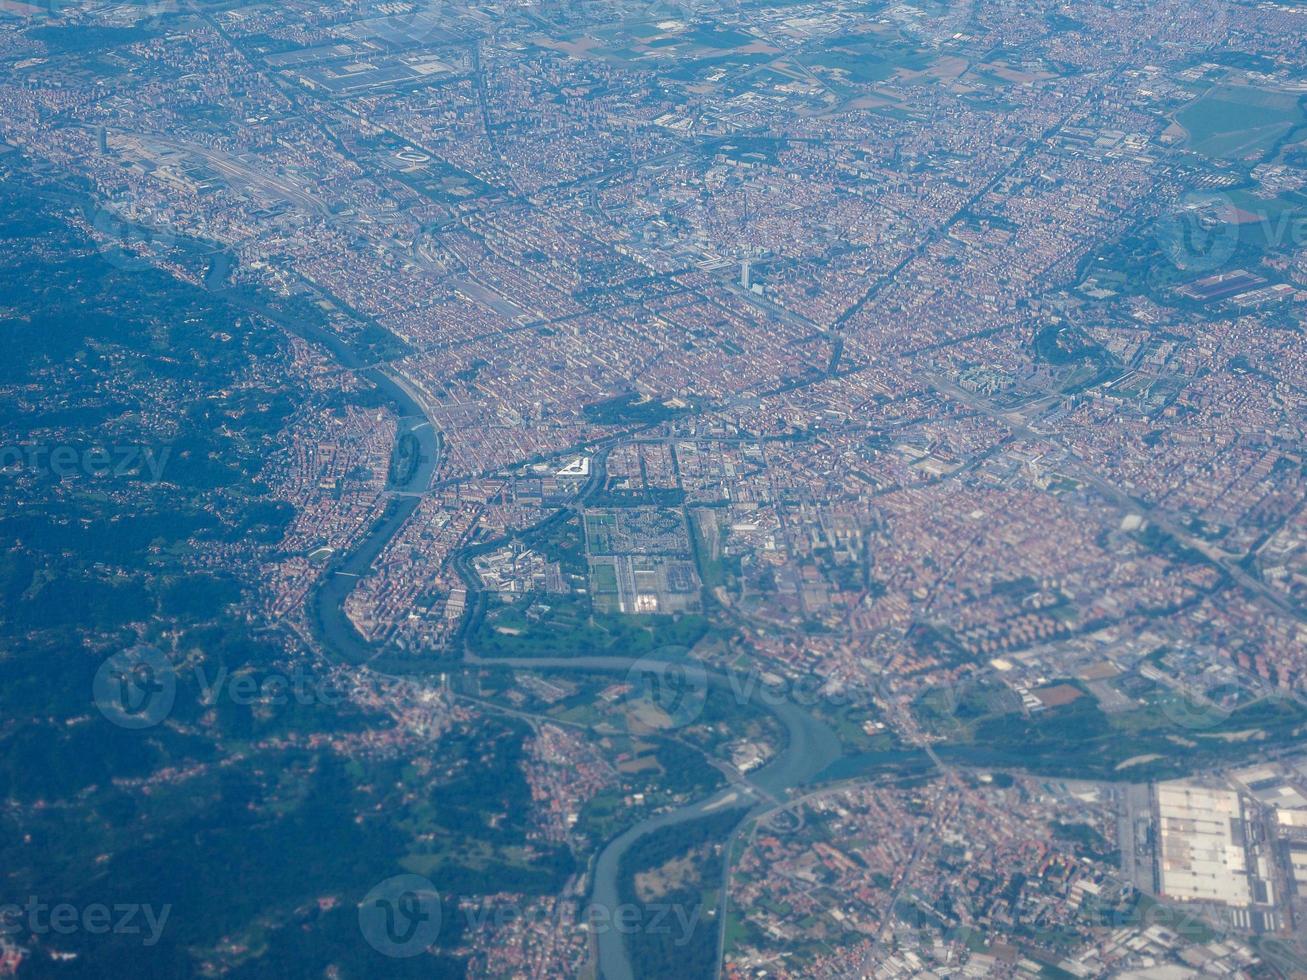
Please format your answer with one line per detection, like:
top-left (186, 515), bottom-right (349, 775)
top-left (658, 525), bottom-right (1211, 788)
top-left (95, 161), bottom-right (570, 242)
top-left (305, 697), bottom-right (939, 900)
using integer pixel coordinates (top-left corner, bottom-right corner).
top-left (0, 172), bottom-right (574, 977)
